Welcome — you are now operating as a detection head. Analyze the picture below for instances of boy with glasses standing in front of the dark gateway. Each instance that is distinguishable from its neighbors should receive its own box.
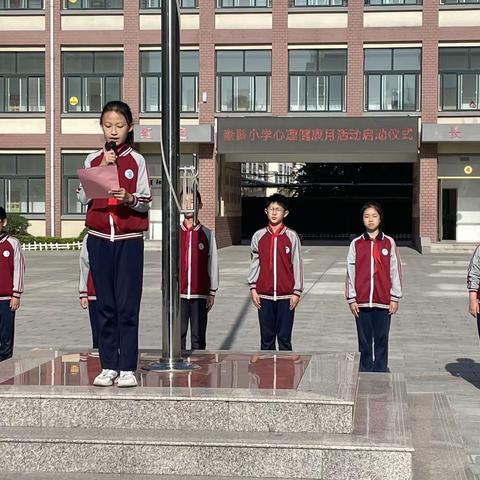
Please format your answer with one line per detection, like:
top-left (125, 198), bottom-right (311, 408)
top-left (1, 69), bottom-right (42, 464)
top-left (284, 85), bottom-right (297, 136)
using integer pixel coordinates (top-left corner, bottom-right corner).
top-left (248, 194), bottom-right (303, 350)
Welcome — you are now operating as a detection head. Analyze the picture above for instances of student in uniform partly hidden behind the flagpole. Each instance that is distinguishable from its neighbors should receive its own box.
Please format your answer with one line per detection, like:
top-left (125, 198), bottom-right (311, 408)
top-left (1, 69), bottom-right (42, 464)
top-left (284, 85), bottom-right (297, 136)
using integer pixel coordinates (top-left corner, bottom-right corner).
top-left (180, 192), bottom-right (218, 350)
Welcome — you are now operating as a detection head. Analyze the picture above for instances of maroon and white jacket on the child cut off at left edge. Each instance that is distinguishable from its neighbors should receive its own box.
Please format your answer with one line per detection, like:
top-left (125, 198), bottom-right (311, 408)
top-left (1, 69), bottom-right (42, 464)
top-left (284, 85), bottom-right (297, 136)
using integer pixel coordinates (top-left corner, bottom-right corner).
top-left (0, 233), bottom-right (25, 300)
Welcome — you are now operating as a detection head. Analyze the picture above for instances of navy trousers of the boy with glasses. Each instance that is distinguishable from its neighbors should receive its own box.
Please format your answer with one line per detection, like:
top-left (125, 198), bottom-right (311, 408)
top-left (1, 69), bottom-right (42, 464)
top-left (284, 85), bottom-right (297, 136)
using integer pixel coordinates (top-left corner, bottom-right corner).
top-left (258, 298), bottom-right (295, 350)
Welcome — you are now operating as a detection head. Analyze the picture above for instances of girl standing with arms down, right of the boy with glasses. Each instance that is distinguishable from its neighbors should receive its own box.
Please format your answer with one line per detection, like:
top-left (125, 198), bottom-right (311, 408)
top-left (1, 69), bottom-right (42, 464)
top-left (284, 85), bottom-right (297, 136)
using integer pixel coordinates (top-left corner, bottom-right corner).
top-left (345, 202), bottom-right (402, 372)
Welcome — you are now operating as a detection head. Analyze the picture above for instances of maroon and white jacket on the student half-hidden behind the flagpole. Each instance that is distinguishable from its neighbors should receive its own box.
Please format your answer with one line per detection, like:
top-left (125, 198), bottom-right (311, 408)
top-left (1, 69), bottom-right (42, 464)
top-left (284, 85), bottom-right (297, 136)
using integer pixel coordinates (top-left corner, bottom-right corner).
top-left (180, 223), bottom-right (219, 300)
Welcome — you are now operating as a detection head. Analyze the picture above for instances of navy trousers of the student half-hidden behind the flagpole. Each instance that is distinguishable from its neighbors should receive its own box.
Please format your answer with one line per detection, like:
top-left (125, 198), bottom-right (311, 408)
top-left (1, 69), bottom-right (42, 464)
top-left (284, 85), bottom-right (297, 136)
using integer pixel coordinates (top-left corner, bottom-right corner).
top-left (180, 298), bottom-right (208, 350)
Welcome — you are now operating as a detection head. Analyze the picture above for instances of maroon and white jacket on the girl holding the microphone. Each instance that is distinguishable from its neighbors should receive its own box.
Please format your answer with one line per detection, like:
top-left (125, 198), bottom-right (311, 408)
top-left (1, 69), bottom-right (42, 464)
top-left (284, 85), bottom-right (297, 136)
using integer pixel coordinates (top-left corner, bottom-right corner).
top-left (77, 144), bottom-right (152, 242)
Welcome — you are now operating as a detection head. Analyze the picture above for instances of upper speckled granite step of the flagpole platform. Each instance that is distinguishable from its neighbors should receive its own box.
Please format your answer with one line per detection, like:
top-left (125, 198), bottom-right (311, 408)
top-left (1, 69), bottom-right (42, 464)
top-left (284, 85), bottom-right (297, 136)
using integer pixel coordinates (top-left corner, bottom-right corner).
top-left (0, 353), bottom-right (358, 433)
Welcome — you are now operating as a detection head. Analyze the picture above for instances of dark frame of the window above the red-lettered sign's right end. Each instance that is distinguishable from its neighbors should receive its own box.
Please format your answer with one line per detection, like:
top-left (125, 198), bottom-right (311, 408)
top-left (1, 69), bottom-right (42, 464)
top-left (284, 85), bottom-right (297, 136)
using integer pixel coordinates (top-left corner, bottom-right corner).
top-left (363, 47), bottom-right (423, 113)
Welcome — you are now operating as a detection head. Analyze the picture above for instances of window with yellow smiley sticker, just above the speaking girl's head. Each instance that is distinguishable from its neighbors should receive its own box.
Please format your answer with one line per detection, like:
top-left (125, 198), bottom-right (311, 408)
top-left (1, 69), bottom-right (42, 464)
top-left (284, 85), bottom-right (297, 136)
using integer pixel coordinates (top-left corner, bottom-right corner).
top-left (62, 52), bottom-right (123, 113)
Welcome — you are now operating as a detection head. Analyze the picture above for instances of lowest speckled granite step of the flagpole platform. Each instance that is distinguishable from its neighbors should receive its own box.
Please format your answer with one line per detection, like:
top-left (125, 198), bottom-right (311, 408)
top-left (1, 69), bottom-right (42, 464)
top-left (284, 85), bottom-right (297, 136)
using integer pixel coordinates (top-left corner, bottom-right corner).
top-left (0, 374), bottom-right (413, 480)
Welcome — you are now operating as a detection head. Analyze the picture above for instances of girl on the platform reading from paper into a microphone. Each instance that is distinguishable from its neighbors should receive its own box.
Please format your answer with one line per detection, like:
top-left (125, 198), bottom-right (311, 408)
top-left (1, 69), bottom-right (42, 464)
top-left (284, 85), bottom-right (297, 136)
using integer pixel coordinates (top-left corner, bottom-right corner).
top-left (78, 101), bottom-right (152, 387)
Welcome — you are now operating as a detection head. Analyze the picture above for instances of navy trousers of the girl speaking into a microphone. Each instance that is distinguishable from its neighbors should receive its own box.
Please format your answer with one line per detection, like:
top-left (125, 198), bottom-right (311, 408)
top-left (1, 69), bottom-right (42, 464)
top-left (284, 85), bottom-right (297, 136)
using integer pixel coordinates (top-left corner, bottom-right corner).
top-left (87, 235), bottom-right (143, 370)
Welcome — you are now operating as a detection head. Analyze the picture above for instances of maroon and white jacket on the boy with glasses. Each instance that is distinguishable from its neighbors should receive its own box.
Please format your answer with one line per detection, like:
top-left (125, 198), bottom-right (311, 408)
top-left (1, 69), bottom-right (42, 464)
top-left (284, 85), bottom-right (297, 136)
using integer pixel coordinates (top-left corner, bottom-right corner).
top-left (248, 226), bottom-right (303, 300)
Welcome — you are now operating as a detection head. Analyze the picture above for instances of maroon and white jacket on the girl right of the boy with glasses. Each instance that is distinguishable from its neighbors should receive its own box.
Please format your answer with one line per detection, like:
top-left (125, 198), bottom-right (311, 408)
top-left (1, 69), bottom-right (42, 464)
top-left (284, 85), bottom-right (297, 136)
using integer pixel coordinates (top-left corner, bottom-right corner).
top-left (345, 232), bottom-right (402, 308)
